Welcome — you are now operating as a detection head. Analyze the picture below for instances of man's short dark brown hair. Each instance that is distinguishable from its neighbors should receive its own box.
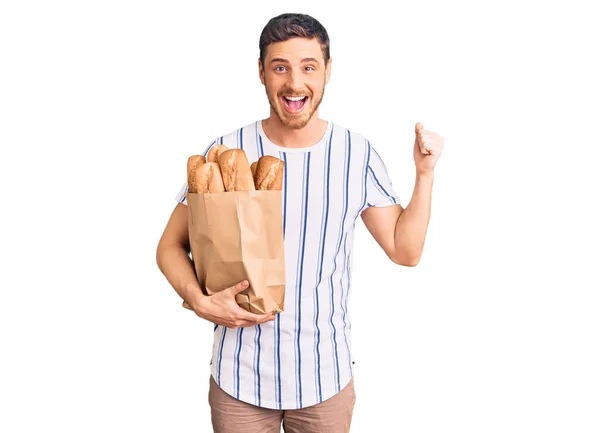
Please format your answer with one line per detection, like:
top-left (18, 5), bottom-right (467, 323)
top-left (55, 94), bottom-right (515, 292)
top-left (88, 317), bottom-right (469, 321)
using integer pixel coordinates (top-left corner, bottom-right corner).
top-left (258, 14), bottom-right (330, 65)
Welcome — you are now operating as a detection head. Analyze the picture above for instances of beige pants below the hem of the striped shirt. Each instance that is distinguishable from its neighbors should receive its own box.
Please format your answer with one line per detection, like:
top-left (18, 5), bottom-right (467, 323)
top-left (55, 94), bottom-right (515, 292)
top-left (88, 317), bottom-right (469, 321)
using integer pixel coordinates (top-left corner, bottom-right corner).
top-left (208, 376), bottom-right (356, 433)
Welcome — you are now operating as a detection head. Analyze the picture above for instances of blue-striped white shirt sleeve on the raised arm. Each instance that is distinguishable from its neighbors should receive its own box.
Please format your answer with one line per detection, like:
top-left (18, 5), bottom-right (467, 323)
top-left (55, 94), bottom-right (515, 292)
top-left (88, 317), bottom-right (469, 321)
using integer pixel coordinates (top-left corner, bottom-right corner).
top-left (365, 143), bottom-right (400, 207)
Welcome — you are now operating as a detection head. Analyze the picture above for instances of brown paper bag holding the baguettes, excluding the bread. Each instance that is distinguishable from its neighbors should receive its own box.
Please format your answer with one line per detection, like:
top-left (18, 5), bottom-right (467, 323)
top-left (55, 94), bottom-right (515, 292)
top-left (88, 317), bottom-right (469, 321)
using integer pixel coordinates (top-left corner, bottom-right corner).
top-left (183, 190), bottom-right (285, 314)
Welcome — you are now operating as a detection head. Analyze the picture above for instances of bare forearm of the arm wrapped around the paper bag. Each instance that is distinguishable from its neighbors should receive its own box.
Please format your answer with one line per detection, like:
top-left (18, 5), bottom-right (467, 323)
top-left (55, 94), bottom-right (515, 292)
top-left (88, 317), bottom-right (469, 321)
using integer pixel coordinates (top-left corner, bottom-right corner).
top-left (156, 245), bottom-right (204, 307)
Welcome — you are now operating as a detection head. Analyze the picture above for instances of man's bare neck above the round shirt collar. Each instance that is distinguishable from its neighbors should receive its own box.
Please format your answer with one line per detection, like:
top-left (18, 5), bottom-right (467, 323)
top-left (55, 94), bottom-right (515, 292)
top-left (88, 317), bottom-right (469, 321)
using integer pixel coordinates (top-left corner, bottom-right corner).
top-left (262, 110), bottom-right (328, 148)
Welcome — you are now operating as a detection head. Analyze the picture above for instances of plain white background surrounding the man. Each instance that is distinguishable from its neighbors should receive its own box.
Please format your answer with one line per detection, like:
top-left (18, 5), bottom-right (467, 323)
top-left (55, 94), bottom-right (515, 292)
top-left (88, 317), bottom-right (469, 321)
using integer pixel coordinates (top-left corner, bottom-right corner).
top-left (0, 0), bottom-right (600, 433)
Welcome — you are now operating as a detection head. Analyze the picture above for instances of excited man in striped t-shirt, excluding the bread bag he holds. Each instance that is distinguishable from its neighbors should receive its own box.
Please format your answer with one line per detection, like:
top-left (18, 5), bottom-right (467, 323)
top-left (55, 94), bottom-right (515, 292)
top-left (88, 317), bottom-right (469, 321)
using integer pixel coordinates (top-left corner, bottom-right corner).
top-left (157, 14), bottom-right (443, 433)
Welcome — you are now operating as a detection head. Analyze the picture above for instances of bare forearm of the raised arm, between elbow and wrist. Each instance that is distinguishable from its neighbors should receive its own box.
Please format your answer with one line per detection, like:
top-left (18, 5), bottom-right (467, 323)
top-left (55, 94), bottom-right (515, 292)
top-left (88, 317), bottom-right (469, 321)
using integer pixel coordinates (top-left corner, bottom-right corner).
top-left (394, 173), bottom-right (433, 266)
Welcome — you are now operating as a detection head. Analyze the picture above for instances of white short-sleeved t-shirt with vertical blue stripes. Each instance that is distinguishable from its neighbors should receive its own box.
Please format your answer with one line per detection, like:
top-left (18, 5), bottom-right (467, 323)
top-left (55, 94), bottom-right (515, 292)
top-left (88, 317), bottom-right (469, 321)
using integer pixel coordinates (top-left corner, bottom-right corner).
top-left (177, 120), bottom-right (399, 409)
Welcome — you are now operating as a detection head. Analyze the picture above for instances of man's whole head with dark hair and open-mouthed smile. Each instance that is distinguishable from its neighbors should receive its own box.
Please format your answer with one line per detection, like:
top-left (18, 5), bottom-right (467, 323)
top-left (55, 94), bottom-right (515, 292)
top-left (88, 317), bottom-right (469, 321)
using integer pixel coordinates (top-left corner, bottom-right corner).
top-left (258, 14), bottom-right (331, 129)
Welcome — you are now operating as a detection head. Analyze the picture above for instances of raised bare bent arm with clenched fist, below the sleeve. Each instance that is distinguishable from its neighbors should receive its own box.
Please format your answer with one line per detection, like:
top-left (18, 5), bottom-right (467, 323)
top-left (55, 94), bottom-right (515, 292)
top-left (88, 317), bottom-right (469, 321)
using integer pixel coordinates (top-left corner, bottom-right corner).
top-left (361, 123), bottom-right (444, 266)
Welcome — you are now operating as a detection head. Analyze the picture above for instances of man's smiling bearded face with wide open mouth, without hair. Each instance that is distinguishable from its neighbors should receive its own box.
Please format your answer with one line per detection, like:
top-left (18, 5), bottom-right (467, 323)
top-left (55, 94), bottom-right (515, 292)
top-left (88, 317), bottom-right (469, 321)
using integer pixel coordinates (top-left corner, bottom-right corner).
top-left (259, 38), bottom-right (331, 129)
